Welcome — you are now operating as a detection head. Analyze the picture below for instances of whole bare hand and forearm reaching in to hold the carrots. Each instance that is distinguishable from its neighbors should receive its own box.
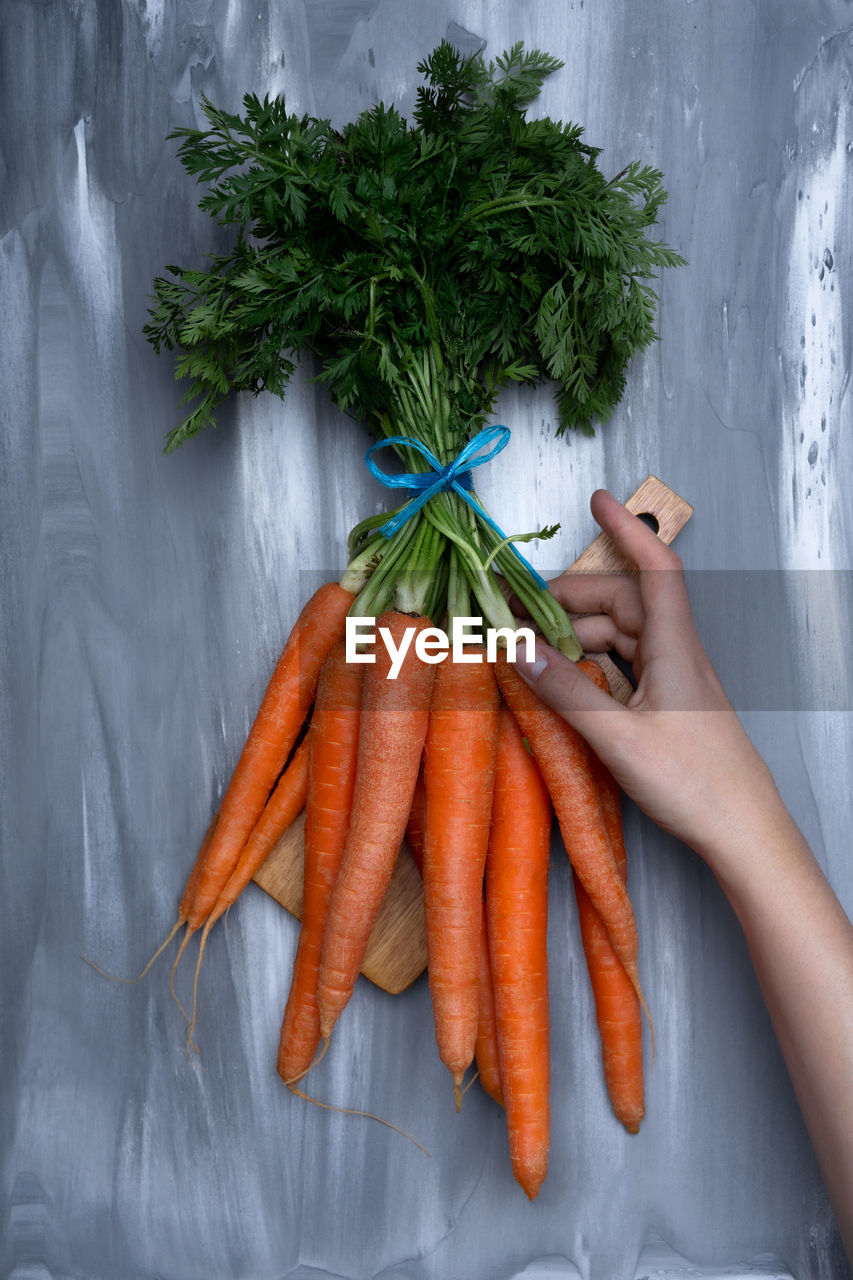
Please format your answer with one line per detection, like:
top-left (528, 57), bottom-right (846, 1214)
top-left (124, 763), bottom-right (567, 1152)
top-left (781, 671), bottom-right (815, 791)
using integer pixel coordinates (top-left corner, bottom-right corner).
top-left (516, 489), bottom-right (853, 1258)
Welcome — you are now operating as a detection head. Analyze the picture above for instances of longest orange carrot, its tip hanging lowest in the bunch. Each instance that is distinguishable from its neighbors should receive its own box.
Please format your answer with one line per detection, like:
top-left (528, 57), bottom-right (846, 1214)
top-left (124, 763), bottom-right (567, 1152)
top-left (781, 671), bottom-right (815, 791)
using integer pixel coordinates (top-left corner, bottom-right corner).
top-left (485, 705), bottom-right (551, 1199)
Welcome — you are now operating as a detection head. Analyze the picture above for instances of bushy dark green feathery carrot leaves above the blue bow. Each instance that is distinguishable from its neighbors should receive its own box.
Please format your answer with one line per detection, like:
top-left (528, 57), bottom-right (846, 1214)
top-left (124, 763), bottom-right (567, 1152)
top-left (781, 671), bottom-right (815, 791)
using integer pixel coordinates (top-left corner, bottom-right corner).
top-left (145, 41), bottom-right (683, 453)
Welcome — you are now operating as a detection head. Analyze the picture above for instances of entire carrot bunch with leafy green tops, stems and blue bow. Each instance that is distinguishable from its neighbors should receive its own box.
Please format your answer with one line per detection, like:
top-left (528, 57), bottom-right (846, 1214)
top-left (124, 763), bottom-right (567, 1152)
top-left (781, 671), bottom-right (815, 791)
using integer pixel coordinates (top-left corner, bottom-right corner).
top-left (131, 41), bottom-right (683, 1197)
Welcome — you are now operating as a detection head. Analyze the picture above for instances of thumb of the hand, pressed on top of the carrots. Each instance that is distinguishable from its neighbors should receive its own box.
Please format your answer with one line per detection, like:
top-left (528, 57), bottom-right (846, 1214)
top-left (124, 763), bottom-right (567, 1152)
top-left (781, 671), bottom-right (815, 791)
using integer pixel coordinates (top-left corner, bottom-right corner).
top-left (515, 636), bottom-right (629, 762)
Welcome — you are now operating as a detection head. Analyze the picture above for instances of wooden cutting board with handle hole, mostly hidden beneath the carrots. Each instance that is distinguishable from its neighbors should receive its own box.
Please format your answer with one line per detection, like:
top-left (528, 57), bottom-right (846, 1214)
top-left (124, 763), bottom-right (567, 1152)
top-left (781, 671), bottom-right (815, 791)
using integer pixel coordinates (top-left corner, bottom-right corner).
top-left (255, 476), bottom-right (693, 995)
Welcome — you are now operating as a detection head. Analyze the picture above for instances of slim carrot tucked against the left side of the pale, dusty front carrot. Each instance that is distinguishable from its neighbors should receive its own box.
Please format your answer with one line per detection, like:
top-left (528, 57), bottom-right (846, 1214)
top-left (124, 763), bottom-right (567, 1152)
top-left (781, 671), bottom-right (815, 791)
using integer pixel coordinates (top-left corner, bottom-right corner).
top-left (278, 644), bottom-right (364, 1083)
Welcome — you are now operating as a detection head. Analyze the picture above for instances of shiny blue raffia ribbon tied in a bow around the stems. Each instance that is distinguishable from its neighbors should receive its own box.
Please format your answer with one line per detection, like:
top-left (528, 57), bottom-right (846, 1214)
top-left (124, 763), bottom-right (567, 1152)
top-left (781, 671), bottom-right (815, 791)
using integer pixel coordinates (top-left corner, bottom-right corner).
top-left (364, 425), bottom-right (548, 591)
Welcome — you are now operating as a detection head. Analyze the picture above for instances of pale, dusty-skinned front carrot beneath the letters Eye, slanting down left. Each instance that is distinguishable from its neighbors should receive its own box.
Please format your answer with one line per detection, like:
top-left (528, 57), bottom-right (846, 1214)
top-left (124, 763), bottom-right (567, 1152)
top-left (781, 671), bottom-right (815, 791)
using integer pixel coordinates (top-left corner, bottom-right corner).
top-left (318, 612), bottom-right (435, 1041)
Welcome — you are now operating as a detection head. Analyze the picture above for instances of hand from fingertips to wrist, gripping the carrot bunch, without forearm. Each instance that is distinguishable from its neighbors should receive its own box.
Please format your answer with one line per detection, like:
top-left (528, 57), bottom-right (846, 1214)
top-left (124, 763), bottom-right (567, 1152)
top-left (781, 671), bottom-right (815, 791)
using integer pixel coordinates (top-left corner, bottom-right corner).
top-left (516, 489), bottom-right (784, 872)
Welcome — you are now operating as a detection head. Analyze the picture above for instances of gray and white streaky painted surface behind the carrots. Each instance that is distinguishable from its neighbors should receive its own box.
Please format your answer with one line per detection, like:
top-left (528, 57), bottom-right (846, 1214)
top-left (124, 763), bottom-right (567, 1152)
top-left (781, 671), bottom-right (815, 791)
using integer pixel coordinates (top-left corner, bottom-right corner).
top-left (0, 0), bottom-right (853, 1280)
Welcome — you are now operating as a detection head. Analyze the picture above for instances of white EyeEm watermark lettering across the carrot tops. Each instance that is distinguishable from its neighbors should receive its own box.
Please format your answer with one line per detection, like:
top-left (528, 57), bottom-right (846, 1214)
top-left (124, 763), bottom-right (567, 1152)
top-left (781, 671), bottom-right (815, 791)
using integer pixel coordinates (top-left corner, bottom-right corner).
top-left (346, 617), bottom-right (535, 680)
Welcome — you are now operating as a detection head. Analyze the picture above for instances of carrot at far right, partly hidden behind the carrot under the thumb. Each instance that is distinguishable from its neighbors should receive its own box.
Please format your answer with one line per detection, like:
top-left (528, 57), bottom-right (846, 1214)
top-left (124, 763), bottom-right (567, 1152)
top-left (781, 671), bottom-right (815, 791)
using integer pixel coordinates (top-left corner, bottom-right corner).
top-left (574, 662), bottom-right (637, 1133)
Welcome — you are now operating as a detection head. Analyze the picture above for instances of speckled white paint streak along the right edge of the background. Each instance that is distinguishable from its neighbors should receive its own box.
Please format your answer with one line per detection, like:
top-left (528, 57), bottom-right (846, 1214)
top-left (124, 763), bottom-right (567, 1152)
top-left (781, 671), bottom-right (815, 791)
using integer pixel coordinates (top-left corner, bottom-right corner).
top-left (777, 40), bottom-right (853, 926)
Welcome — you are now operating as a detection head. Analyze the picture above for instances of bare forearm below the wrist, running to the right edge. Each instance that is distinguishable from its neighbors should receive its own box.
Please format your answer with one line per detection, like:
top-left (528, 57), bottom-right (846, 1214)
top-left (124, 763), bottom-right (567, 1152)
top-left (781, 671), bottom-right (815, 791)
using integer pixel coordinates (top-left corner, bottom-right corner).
top-left (699, 787), bottom-right (853, 1257)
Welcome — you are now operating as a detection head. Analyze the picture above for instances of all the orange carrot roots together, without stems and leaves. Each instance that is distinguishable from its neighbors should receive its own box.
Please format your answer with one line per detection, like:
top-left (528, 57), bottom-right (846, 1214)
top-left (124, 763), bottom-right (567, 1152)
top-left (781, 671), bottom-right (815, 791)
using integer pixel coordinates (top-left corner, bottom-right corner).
top-left (163, 582), bottom-right (644, 1198)
